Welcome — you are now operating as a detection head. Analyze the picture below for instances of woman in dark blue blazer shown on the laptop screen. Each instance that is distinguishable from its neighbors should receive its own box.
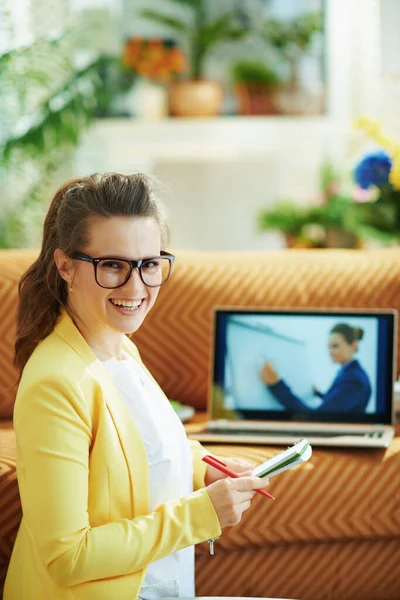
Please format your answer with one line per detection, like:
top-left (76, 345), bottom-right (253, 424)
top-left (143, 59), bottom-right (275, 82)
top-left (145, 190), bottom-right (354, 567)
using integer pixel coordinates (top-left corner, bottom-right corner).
top-left (261, 323), bottom-right (371, 413)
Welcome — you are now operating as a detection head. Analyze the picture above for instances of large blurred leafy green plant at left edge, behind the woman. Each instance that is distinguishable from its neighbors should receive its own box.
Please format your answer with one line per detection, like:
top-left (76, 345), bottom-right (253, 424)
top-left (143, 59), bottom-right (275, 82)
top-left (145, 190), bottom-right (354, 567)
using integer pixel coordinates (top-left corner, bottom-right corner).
top-left (0, 31), bottom-right (101, 248)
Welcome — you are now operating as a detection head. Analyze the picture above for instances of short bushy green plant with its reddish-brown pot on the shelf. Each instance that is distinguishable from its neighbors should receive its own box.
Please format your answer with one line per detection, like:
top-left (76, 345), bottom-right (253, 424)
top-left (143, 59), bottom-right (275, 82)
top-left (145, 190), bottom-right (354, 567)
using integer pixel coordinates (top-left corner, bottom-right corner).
top-left (231, 60), bottom-right (279, 115)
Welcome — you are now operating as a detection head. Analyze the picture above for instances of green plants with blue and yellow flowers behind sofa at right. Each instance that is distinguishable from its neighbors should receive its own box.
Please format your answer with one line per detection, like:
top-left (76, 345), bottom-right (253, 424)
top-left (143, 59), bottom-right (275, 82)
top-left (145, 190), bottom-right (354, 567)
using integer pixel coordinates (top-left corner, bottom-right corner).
top-left (258, 117), bottom-right (400, 248)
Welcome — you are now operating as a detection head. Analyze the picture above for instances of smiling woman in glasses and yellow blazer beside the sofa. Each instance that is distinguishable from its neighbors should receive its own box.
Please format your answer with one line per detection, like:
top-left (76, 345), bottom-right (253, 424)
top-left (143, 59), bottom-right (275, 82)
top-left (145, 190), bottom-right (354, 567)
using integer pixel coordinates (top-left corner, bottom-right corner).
top-left (4, 174), bottom-right (267, 600)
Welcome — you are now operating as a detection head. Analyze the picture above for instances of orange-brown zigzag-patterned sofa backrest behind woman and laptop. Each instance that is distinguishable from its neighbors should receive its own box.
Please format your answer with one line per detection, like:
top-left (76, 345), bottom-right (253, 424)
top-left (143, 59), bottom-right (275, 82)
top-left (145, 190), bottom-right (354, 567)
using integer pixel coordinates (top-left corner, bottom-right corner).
top-left (0, 248), bottom-right (400, 418)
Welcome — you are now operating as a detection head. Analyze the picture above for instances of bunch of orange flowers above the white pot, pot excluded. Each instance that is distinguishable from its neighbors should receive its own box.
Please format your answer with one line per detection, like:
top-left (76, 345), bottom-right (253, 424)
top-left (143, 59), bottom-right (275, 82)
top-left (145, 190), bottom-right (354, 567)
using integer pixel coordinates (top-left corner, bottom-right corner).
top-left (123, 37), bottom-right (188, 84)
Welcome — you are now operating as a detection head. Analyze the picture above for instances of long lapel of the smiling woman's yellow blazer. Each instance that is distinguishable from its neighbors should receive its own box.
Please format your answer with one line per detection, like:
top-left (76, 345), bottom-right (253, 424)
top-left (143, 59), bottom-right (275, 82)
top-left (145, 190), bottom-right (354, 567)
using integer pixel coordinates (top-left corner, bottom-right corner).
top-left (55, 310), bottom-right (150, 516)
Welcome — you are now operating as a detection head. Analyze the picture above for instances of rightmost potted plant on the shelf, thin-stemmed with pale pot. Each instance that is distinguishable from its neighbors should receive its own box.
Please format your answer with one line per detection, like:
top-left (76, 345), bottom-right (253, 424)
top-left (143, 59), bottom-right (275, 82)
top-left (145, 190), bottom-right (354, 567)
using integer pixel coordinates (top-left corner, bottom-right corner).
top-left (262, 12), bottom-right (322, 114)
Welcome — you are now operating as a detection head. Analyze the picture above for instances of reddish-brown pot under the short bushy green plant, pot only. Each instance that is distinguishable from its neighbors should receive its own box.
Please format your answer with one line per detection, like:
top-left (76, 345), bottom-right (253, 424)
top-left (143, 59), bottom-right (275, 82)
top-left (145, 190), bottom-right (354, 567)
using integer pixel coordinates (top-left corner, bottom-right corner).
top-left (234, 83), bottom-right (278, 115)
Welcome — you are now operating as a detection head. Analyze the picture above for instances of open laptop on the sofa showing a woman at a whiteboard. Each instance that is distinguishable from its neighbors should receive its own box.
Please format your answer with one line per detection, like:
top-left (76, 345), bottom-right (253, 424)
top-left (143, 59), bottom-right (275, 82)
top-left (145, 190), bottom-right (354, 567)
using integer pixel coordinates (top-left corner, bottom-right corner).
top-left (189, 307), bottom-right (397, 448)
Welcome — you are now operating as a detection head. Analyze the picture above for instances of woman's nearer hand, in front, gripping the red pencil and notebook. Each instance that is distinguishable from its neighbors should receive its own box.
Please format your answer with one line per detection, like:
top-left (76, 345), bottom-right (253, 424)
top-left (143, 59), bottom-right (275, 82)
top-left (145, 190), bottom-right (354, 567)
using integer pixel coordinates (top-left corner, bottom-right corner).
top-left (206, 477), bottom-right (269, 529)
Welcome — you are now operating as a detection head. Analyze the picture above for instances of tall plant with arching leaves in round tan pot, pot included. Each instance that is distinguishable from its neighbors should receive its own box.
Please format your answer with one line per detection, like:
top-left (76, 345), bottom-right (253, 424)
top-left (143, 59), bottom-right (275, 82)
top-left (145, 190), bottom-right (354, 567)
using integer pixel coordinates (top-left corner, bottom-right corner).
top-left (140, 0), bottom-right (247, 117)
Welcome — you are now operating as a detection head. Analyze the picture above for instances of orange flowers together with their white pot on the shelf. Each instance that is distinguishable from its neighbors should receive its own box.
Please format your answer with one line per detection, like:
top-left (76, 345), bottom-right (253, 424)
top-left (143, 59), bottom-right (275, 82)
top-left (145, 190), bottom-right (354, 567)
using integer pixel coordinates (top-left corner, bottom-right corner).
top-left (123, 37), bottom-right (187, 119)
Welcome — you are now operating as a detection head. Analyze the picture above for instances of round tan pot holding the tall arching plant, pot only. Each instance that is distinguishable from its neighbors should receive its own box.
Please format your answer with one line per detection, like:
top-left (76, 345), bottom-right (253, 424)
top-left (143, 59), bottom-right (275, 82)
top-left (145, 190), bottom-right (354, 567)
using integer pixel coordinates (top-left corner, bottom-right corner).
top-left (169, 80), bottom-right (223, 117)
